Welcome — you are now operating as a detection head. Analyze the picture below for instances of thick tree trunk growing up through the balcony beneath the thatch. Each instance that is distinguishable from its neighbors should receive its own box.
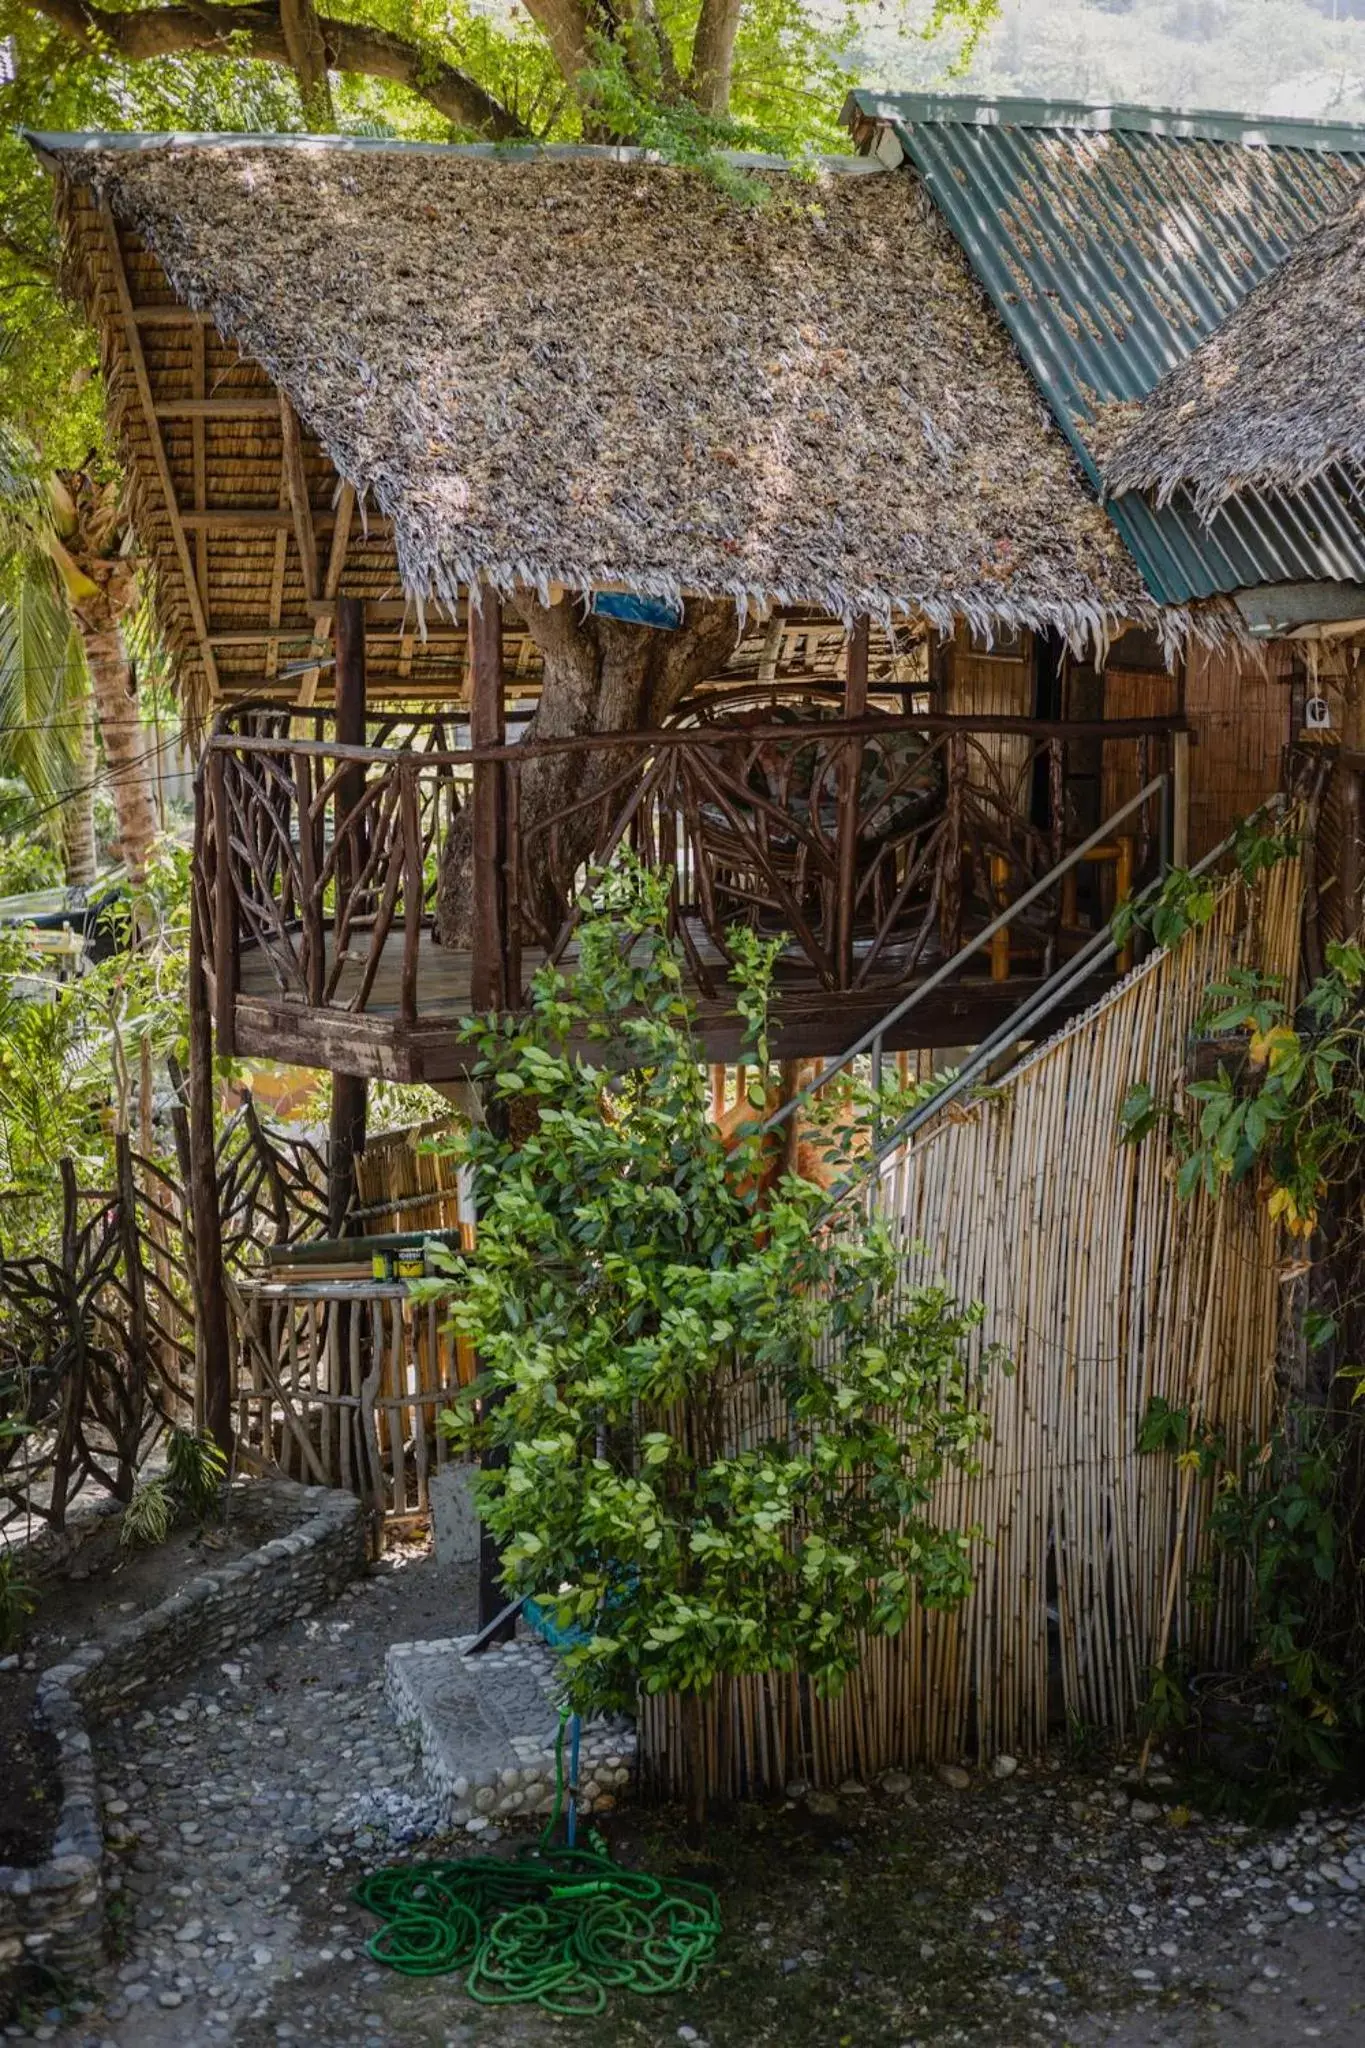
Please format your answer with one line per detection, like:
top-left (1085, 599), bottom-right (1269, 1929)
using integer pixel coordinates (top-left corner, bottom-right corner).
top-left (436, 594), bottom-right (739, 946)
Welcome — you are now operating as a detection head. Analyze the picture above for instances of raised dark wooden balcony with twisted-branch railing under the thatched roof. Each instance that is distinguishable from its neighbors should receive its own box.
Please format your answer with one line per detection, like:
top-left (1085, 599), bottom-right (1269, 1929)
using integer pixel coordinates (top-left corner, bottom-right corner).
top-left (194, 711), bottom-right (1183, 1081)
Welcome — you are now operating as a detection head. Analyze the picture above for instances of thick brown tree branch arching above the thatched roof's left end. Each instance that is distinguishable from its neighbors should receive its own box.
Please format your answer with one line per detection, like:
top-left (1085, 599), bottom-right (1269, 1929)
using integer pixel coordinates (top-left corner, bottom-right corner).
top-left (25, 0), bottom-right (528, 141)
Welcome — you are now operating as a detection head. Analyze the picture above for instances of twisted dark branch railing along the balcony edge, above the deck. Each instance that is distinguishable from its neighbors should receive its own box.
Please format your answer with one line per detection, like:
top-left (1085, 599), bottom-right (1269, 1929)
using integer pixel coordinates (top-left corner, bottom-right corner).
top-left (201, 715), bottom-right (1177, 1024)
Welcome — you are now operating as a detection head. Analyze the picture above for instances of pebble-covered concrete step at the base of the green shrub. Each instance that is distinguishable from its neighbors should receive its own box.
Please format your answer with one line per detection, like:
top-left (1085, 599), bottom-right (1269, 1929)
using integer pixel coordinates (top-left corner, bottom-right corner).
top-left (385, 1636), bottom-right (634, 1835)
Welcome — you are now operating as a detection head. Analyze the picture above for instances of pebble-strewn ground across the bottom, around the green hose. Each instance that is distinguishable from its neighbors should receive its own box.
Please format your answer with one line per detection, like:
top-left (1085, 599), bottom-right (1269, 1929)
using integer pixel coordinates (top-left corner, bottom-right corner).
top-left (8, 1552), bottom-right (1365, 2048)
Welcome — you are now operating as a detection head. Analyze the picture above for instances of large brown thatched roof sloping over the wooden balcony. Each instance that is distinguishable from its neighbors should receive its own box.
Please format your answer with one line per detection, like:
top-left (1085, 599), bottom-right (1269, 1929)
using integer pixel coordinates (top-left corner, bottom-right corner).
top-left (41, 137), bottom-right (1152, 679)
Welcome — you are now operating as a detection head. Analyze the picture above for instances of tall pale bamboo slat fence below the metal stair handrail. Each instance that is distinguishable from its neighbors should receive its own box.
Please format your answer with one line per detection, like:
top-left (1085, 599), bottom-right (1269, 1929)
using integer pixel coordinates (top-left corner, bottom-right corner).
top-left (641, 860), bottom-right (1302, 1792)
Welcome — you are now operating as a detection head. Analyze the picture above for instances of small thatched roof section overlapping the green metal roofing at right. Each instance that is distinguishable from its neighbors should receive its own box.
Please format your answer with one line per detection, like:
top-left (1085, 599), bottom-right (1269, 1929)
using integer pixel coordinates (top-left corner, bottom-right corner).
top-left (1105, 199), bottom-right (1365, 514)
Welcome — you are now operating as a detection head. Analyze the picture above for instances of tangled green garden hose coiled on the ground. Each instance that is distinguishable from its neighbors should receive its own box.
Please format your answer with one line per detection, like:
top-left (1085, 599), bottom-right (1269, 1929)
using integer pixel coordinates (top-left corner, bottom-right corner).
top-left (352, 1718), bottom-right (720, 2015)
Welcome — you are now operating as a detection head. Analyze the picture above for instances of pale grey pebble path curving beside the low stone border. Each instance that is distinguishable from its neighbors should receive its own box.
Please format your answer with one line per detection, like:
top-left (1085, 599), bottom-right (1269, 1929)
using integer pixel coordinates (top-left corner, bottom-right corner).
top-left (6, 1552), bottom-right (475, 2048)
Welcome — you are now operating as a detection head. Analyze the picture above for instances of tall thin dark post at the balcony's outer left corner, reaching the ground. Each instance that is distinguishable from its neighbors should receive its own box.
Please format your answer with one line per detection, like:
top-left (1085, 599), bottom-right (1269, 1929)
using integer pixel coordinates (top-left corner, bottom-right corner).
top-left (188, 780), bottom-right (233, 1456)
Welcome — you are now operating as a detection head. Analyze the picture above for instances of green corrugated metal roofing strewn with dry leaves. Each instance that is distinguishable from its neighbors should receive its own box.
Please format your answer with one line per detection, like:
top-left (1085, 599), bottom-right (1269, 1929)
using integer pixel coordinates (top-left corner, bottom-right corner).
top-left (845, 92), bottom-right (1365, 604)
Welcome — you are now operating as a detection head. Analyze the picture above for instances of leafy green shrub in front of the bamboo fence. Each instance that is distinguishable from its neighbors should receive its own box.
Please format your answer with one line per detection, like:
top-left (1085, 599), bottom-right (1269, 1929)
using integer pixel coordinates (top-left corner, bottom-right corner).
top-left (428, 868), bottom-right (986, 1835)
